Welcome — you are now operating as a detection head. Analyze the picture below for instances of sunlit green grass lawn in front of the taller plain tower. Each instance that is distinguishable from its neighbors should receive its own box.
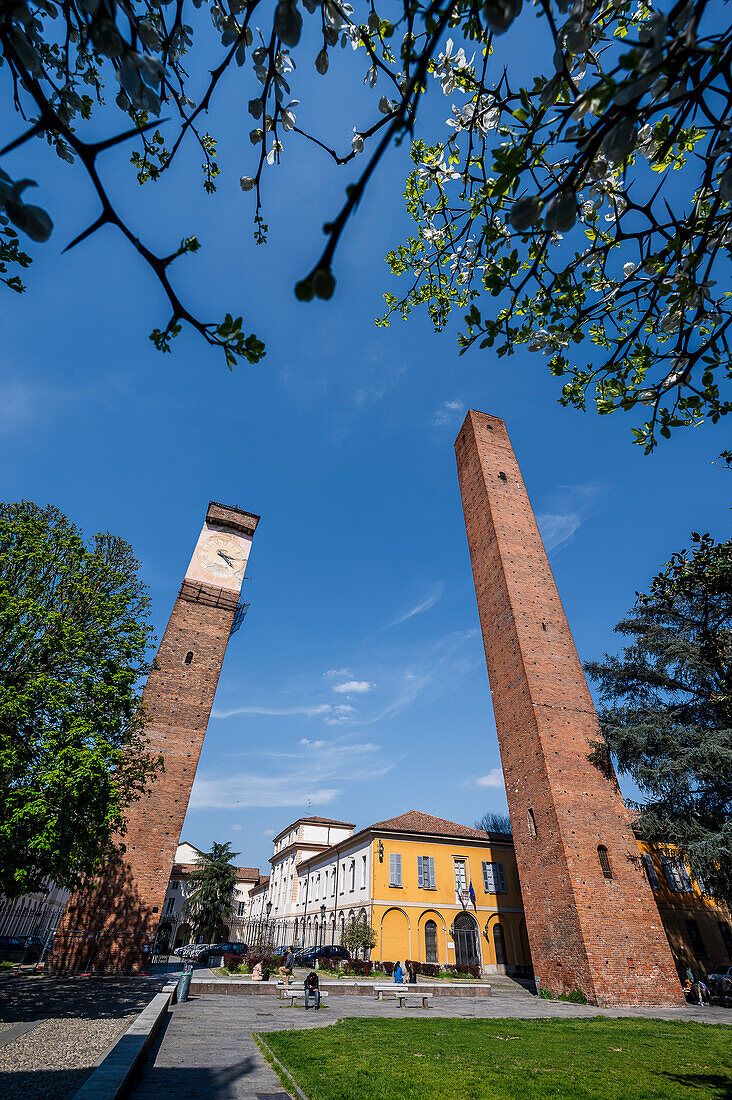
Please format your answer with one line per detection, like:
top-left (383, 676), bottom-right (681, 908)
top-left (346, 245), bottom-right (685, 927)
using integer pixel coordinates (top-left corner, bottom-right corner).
top-left (262, 1016), bottom-right (732, 1100)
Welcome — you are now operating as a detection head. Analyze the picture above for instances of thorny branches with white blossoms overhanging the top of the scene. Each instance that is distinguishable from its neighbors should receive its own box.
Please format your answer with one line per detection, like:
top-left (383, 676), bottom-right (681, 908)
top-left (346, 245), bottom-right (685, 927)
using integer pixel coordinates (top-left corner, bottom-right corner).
top-left (0, 0), bottom-right (732, 449)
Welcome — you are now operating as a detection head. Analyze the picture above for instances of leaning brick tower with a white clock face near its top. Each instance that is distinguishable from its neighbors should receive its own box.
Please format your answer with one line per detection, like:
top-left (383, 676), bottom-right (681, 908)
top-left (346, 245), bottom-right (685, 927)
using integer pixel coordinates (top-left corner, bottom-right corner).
top-left (50, 503), bottom-right (259, 971)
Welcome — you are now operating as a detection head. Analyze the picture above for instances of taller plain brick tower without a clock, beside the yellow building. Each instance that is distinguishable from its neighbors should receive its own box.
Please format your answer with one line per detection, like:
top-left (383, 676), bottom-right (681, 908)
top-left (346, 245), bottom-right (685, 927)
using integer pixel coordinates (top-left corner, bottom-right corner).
top-left (455, 410), bottom-right (684, 1005)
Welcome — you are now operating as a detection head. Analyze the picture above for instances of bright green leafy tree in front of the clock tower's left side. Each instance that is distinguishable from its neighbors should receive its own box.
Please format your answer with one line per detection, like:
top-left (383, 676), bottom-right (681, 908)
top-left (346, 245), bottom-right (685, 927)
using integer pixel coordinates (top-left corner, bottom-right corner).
top-left (0, 501), bottom-right (161, 898)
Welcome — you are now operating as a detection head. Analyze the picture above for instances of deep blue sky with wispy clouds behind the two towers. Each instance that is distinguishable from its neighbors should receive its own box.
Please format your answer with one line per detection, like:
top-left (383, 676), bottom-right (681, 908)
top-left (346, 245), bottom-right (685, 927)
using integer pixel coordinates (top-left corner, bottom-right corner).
top-left (0, 12), bottom-right (729, 867)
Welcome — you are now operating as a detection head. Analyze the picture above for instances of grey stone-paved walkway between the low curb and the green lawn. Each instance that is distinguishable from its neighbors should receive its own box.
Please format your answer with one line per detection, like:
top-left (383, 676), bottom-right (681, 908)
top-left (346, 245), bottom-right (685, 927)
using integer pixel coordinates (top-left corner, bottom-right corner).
top-left (130, 993), bottom-right (732, 1100)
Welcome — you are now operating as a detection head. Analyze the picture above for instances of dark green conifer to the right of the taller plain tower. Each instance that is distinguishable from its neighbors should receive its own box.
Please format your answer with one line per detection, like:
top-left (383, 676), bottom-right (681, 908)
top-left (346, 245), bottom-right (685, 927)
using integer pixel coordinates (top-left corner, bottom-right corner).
top-left (587, 534), bottom-right (732, 902)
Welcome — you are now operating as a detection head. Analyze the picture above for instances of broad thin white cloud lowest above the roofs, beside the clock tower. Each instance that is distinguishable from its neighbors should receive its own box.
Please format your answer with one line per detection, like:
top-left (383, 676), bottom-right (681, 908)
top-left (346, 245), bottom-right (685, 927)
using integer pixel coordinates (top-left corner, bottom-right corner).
top-left (190, 740), bottom-right (397, 810)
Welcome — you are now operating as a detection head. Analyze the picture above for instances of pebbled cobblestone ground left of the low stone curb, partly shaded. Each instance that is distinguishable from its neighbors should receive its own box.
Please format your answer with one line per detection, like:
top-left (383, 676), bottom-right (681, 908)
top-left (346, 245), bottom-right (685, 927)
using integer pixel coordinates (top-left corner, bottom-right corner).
top-left (0, 975), bottom-right (163, 1100)
